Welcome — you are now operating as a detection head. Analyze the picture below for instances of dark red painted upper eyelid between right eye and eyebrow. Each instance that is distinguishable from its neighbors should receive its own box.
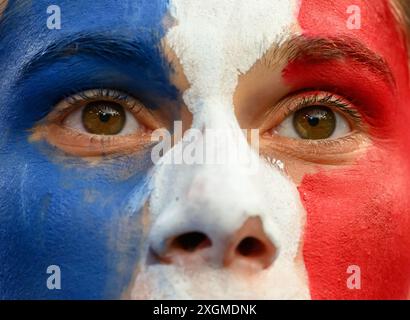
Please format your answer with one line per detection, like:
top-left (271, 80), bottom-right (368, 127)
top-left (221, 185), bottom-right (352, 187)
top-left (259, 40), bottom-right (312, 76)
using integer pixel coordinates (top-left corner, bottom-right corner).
top-left (283, 59), bottom-right (397, 141)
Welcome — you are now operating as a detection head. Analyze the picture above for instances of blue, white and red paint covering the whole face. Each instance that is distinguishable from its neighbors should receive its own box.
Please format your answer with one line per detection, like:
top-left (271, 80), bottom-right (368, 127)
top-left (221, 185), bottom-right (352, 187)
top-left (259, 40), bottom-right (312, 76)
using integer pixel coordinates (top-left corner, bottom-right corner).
top-left (0, 0), bottom-right (410, 299)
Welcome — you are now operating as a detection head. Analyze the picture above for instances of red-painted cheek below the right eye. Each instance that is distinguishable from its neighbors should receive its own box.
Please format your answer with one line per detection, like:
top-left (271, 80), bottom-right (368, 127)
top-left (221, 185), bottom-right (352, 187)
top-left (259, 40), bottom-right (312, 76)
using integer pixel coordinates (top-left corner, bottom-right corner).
top-left (299, 152), bottom-right (410, 299)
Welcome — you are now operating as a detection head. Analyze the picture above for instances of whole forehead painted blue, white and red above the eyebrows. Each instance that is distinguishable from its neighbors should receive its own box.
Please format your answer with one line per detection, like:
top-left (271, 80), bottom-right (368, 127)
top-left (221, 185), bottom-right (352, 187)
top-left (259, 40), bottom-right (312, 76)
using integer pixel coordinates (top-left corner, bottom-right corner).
top-left (0, 0), bottom-right (406, 112)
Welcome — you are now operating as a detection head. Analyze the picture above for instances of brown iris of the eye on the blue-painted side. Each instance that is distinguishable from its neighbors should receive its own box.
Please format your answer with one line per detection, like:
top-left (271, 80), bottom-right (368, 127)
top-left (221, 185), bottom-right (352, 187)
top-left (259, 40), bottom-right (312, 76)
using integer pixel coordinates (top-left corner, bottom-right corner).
top-left (82, 101), bottom-right (125, 135)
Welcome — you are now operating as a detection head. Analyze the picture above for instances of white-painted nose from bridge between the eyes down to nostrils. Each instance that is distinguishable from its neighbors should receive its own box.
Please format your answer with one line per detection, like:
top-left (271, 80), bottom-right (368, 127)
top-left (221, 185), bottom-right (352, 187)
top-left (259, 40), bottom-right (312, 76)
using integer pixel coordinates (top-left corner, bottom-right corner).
top-left (149, 99), bottom-right (301, 263)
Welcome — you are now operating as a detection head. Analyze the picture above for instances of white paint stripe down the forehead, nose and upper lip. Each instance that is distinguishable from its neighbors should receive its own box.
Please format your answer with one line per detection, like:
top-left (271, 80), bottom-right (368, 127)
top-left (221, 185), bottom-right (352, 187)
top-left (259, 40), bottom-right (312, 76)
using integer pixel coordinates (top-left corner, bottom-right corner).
top-left (131, 0), bottom-right (309, 299)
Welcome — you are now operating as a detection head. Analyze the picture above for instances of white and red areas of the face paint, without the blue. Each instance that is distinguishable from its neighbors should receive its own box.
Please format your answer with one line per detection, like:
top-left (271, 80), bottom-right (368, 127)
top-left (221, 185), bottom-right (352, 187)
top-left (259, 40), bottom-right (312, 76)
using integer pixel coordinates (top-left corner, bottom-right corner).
top-left (132, 0), bottom-right (410, 299)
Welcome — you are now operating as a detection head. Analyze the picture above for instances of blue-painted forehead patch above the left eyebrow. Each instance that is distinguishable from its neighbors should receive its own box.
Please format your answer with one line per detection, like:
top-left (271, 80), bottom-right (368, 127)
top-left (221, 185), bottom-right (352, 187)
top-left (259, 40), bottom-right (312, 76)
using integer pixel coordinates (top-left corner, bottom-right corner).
top-left (0, 0), bottom-right (168, 46)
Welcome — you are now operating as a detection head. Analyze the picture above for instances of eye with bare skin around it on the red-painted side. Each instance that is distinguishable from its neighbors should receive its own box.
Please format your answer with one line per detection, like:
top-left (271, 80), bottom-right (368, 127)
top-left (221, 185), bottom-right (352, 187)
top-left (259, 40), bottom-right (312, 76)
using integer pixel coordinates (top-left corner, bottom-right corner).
top-left (260, 91), bottom-right (371, 165)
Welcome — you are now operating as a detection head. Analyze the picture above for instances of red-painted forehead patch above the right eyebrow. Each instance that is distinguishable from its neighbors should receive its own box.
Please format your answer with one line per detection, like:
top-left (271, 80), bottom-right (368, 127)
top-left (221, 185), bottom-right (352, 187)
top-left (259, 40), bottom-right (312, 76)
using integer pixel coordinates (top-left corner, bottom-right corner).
top-left (298, 0), bottom-right (406, 72)
